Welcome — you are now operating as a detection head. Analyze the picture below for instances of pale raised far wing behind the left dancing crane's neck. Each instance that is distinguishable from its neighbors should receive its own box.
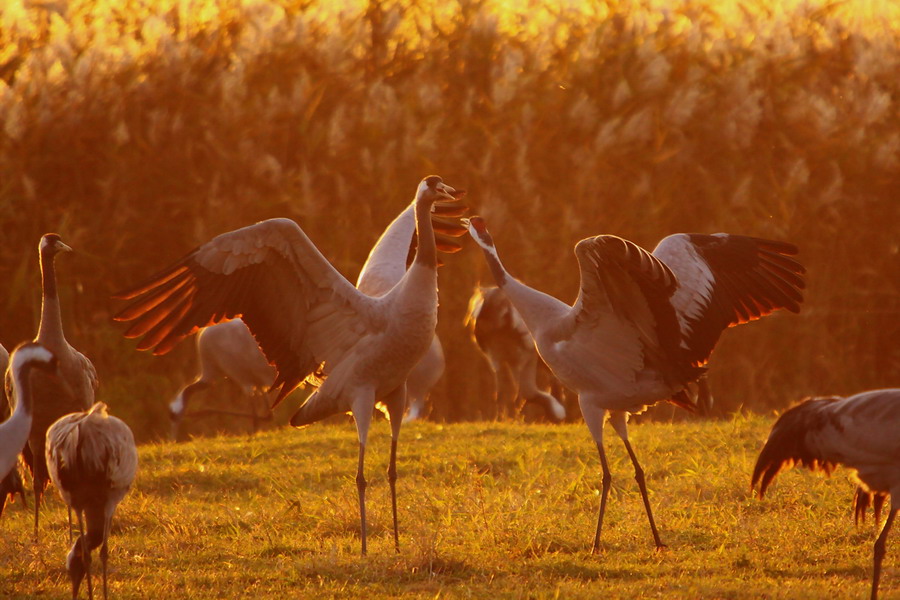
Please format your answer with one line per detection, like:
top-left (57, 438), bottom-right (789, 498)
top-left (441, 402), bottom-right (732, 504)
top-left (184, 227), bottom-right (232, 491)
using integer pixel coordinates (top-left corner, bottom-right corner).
top-left (356, 200), bottom-right (468, 296)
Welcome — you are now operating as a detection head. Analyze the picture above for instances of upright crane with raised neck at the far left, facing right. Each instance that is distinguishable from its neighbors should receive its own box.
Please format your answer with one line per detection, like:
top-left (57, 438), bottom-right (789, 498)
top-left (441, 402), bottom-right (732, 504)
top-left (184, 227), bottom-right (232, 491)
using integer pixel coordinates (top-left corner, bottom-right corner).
top-left (4, 233), bottom-right (98, 538)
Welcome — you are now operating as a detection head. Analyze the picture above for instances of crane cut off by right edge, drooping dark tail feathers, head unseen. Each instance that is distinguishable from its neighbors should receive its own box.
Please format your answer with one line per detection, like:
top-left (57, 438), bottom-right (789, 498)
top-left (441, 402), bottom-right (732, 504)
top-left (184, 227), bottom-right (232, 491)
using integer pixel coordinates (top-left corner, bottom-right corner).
top-left (751, 388), bottom-right (900, 600)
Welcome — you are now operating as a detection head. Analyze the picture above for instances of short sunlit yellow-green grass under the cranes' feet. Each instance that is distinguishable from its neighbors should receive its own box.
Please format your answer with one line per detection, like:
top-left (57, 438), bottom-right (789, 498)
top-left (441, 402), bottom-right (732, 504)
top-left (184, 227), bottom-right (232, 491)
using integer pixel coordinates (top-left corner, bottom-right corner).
top-left (0, 416), bottom-right (884, 598)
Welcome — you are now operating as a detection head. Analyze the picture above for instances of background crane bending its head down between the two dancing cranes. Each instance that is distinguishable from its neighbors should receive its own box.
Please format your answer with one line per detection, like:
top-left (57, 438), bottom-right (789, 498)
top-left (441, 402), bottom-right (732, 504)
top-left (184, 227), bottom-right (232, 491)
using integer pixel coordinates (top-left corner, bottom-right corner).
top-left (464, 286), bottom-right (566, 423)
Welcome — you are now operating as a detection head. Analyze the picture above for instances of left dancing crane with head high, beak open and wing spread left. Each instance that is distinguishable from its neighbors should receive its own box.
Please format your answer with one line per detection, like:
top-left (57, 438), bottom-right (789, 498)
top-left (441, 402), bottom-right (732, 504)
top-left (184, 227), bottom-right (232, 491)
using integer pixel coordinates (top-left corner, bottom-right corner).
top-left (116, 175), bottom-right (465, 554)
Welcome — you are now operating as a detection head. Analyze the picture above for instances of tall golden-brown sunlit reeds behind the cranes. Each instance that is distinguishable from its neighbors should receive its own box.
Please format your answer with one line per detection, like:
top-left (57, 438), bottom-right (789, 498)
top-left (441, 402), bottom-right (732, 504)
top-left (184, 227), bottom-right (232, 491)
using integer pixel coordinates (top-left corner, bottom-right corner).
top-left (0, 0), bottom-right (900, 439)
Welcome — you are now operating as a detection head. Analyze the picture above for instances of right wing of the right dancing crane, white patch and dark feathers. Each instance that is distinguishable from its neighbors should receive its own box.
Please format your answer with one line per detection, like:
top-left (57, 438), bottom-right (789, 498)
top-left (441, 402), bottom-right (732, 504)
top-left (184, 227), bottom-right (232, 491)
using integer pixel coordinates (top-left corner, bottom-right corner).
top-left (653, 233), bottom-right (805, 365)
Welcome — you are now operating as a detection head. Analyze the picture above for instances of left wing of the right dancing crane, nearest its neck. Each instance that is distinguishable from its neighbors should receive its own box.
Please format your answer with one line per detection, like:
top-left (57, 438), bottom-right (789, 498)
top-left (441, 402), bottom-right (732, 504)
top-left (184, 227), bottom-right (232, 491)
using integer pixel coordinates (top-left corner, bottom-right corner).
top-left (573, 235), bottom-right (699, 392)
